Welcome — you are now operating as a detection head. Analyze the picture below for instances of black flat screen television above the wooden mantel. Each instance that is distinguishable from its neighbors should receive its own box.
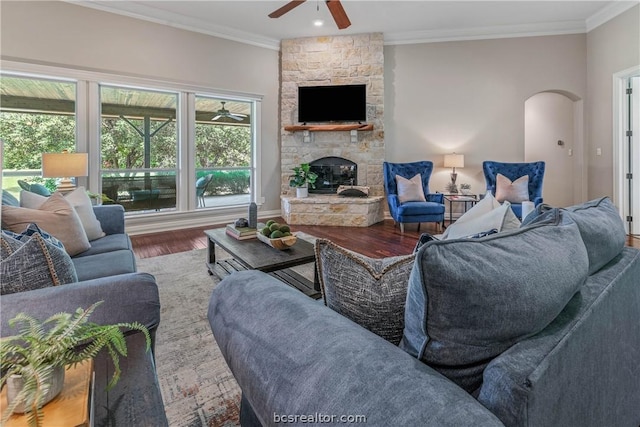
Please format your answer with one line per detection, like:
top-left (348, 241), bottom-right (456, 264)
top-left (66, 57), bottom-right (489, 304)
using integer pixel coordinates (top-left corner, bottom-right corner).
top-left (298, 84), bottom-right (367, 123)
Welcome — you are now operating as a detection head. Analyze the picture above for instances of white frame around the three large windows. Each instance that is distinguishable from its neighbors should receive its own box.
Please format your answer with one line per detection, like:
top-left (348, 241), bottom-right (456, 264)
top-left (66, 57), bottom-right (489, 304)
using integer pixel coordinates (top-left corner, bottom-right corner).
top-left (0, 60), bottom-right (262, 234)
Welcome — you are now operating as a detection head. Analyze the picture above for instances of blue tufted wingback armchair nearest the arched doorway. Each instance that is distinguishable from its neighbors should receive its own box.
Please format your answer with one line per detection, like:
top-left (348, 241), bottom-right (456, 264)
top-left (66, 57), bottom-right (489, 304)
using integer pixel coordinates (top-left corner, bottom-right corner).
top-left (482, 160), bottom-right (545, 218)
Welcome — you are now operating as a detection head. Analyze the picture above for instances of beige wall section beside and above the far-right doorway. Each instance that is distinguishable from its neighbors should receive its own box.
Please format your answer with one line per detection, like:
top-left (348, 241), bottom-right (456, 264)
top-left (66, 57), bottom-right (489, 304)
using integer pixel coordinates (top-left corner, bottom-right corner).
top-left (586, 6), bottom-right (640, 199)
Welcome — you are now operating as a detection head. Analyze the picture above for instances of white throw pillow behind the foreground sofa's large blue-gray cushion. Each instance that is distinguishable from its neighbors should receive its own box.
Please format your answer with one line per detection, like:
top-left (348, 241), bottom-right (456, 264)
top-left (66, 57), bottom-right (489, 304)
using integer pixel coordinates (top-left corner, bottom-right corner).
top-left (442, 202), bottom-right (520, 240)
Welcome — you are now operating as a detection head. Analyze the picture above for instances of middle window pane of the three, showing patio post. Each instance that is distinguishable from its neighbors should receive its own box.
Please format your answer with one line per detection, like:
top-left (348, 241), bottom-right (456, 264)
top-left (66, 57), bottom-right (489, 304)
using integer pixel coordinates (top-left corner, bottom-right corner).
top-left (100, 86), bottom-right (178, 213)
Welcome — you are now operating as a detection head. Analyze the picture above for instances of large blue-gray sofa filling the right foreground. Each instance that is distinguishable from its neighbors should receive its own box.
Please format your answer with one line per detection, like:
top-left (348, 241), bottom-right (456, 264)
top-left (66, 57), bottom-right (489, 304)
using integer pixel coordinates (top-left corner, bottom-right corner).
top-left (208, 200), bottom-right (640, 427)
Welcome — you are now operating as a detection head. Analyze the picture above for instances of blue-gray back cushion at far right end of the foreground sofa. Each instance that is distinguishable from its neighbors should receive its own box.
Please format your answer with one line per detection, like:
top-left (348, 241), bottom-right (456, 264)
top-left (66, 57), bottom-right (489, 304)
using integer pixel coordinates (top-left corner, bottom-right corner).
top-left (523, 197), bottom-right (627, 275)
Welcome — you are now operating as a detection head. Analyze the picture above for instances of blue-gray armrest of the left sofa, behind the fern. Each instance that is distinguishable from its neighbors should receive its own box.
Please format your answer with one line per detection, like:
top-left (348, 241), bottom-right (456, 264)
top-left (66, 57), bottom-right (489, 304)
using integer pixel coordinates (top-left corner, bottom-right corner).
top-left (0, 273), bottom-right (160, 348)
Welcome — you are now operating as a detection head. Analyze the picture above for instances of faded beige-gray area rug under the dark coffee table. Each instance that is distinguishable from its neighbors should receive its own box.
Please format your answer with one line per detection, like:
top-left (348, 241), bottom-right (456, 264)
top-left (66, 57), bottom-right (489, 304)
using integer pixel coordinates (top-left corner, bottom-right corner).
top-left (137, 233), bottom-right (315, 427)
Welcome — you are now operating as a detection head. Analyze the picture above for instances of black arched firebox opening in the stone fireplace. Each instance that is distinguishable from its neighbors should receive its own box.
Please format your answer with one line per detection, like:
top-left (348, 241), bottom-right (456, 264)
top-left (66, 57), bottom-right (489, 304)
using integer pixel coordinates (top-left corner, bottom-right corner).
top-left (309, 157), bottom-right (358, 194)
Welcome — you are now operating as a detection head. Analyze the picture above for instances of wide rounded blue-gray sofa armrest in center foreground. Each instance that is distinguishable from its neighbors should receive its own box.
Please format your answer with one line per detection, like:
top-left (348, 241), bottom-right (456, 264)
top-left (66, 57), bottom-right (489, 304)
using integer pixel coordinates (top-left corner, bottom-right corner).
top-left (208, 271), bottom-right (502, 426)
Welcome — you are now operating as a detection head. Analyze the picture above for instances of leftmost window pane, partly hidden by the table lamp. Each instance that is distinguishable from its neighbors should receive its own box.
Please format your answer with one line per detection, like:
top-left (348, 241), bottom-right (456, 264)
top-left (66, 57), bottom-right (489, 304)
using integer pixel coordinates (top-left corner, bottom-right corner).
top-left (0, 74), bottom-right (76, 197)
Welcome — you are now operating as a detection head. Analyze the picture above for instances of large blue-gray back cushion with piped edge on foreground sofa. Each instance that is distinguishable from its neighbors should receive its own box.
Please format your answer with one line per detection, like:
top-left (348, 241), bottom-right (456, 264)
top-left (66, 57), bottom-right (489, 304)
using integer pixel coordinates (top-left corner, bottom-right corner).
top-left (400, 209), bottom-right (588, 393)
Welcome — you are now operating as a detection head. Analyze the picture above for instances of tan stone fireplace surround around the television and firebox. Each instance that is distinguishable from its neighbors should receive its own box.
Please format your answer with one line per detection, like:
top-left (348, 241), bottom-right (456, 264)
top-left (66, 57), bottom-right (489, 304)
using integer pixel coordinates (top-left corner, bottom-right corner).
top-left (280, 33), bottom-right (385, 226)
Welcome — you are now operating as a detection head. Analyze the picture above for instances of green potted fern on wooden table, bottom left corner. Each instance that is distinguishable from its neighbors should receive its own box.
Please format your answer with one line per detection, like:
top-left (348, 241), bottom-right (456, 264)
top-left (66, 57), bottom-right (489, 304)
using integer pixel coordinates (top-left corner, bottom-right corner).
top-left (0, 301), bottom-right (151, 427)
